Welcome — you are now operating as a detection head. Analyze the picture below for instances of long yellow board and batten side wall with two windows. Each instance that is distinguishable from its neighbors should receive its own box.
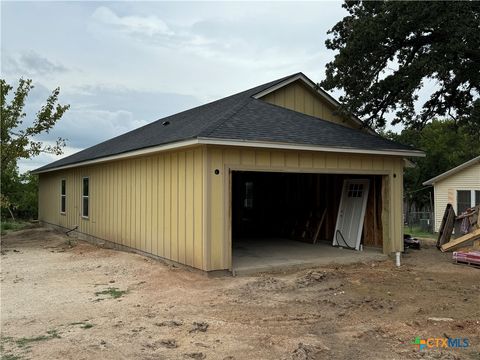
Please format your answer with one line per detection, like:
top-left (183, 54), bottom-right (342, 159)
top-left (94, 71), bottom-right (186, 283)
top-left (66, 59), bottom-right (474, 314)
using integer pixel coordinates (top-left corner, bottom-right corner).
top-left (39, 147), bottom-right (206, 270)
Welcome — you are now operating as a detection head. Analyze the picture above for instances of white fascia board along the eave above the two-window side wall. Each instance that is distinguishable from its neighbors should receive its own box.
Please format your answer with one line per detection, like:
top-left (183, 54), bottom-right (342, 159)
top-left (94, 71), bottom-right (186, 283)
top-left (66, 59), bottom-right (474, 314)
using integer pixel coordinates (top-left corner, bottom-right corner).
top-left (32, 139), bottom-right (199, 174)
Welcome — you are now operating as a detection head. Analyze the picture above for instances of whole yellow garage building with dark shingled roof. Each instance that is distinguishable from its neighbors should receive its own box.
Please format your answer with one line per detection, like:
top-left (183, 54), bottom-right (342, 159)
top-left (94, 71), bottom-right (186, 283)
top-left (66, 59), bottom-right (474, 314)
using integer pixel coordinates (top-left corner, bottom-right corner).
top-left (35, 73), bottom-right (423, 271)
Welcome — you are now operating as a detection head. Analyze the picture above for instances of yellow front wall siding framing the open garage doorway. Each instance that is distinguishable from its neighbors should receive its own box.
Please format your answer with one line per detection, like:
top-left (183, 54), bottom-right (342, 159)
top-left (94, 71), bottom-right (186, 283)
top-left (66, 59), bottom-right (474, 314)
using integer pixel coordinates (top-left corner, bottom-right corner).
top-left (205, 146), bottom-right (404, 270)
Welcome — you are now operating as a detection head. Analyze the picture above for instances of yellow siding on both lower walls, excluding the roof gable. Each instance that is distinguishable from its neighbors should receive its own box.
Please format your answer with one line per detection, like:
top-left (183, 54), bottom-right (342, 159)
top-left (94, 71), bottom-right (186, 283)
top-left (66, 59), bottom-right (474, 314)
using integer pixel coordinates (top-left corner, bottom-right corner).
top-left (39, 142), bottom-right (403, 270)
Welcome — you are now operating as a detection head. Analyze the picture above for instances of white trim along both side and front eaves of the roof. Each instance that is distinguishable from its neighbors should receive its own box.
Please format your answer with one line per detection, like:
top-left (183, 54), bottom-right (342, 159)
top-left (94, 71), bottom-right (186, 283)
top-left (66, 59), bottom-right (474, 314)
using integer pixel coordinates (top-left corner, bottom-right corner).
top-left (32, 137), bottom-right (425, 174)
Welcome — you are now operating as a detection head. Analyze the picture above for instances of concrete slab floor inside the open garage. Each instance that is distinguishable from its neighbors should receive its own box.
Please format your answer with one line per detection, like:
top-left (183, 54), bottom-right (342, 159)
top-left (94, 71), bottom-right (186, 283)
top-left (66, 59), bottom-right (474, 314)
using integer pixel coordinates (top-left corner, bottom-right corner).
top-left (232, 238), bottom-right (388, 275)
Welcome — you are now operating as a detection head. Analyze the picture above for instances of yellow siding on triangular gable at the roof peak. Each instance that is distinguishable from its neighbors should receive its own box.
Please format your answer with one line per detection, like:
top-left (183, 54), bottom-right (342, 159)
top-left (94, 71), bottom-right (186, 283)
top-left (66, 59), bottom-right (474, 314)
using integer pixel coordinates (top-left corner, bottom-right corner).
top-left (262, 81), bottom-right (358, 129)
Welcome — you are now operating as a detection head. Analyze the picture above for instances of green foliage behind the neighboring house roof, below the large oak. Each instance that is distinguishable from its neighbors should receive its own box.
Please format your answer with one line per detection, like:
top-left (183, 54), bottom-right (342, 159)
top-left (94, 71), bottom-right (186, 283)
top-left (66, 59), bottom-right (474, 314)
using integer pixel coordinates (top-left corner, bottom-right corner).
top-left (385, 120), bottom-right (480, 208)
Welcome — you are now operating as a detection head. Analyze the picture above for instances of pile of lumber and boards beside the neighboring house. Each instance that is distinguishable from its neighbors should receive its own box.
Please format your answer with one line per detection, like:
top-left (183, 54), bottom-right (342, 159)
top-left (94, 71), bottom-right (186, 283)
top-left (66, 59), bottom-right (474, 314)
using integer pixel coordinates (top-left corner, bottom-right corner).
top-left (437, 204), bottom-right (480, 252)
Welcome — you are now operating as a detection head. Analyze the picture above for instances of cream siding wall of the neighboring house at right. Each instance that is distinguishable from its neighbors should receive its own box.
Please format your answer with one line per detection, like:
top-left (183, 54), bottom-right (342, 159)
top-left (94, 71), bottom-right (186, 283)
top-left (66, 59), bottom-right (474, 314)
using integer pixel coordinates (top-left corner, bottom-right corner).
top-left (433, 163), bottom-right (480, 232)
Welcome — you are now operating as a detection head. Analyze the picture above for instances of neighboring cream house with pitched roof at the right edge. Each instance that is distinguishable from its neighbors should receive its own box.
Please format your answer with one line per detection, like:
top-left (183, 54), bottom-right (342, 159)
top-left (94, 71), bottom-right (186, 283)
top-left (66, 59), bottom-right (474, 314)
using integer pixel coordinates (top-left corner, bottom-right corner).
top-left (423, 156), bottom-right (480, 231)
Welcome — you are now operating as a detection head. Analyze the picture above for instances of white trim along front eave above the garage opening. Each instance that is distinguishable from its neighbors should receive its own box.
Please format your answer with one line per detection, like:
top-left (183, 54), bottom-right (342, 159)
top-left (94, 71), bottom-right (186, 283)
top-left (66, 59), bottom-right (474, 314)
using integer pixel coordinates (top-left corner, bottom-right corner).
top-left (198, 138), bottom-right (425, 157)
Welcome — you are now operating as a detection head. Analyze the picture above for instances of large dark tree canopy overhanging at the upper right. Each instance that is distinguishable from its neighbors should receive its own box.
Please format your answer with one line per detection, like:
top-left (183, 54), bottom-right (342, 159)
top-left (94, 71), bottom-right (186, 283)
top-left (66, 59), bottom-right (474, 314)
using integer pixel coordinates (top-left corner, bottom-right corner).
top-left (320, 1), bottom-right (480, 132)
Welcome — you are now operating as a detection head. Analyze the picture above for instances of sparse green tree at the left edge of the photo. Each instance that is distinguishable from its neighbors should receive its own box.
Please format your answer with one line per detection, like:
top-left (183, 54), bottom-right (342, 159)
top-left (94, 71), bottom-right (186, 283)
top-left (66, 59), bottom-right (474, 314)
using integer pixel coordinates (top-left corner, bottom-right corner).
top-left (0, 79), bottom-right (70, 218)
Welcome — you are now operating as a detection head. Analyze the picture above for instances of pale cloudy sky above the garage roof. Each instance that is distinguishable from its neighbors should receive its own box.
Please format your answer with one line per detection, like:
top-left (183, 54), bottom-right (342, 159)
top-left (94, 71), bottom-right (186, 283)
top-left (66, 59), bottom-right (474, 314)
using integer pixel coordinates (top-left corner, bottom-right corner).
top-left (1, 1), bottom-right (346, 172)
